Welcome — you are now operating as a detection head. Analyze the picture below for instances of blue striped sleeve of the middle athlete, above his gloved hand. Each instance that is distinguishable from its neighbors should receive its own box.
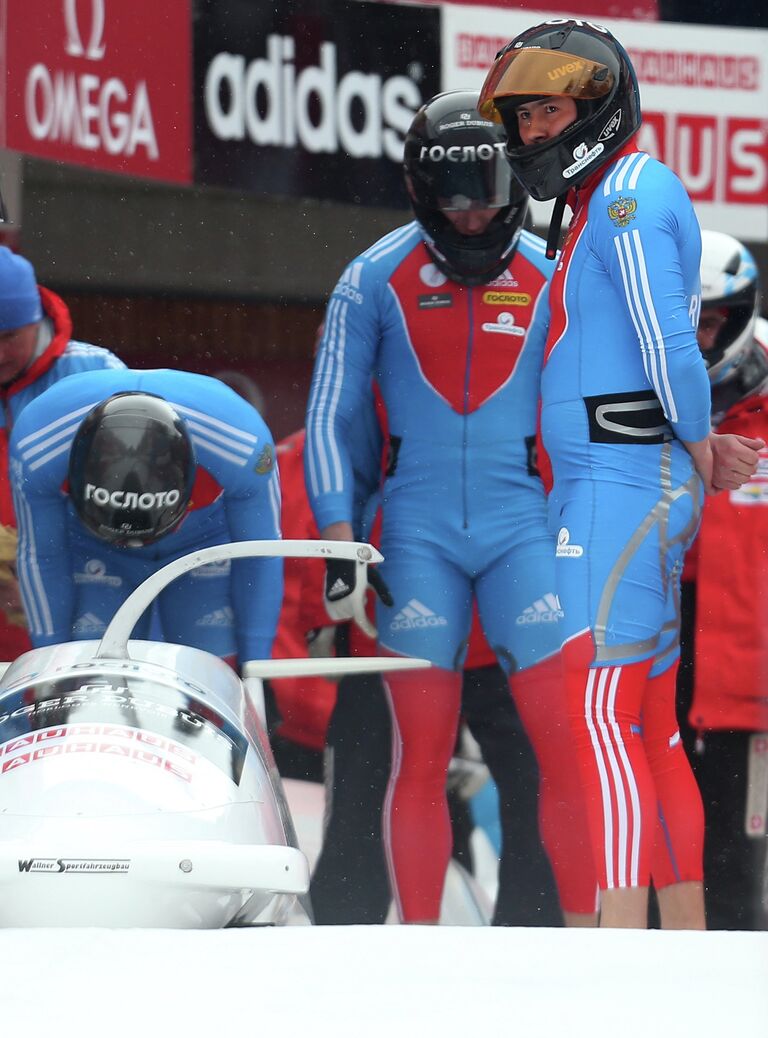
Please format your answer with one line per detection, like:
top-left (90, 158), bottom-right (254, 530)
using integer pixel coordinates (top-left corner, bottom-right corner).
top-left (304, 260), bottom-right (381, 531)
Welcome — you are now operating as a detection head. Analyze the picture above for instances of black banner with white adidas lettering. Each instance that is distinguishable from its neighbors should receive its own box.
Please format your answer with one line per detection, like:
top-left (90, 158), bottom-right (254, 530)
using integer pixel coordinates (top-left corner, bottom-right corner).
top-left (194, 0), bottom-right (440, 208)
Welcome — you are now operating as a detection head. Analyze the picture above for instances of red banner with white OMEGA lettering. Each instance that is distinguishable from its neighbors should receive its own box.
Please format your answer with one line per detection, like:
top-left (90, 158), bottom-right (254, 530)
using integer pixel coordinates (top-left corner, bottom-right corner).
top-left (0, 0), bottom-right (192, 183)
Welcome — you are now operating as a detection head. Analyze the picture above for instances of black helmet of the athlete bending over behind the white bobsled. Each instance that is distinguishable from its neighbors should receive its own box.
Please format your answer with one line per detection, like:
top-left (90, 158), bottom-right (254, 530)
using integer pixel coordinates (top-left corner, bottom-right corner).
top-left (68, 392), bottom-right (195, 548)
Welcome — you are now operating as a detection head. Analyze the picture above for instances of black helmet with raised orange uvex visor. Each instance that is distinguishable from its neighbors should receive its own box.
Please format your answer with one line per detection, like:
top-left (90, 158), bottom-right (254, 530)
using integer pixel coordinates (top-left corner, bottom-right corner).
top-left (478, 19), bottom-right (641, 200)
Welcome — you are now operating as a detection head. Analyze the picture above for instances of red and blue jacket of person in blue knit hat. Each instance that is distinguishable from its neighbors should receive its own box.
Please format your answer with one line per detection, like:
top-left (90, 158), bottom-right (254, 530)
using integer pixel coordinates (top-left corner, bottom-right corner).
top-left (0, 285), bottom-right (125, 659)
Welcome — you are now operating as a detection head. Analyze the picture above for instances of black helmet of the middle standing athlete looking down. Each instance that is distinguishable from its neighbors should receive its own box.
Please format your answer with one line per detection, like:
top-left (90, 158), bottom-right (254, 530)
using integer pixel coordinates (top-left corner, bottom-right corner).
top-left (404, 90), bottom-right (528, 285)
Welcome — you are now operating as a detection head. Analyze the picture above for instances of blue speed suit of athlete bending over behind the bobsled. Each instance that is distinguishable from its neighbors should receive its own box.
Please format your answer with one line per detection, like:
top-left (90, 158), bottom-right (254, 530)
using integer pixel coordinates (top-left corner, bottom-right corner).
top-left (10, 370), bottom-right (282, 663)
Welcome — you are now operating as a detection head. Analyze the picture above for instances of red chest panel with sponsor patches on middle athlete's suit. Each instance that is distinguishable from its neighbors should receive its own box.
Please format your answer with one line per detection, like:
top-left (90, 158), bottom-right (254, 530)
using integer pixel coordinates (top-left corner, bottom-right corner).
top-left (390, 248), bottom-right (544, 413)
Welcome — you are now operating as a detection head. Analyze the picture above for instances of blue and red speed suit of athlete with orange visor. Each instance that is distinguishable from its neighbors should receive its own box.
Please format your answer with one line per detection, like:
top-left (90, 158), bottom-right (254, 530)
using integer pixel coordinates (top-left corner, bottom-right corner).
top-left (542, 142), bottom-right (710, 889)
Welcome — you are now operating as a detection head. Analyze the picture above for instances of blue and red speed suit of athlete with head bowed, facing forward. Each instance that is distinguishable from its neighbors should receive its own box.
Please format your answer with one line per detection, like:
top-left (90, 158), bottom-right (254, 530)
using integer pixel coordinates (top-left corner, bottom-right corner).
top-left (305, 222), bottom-right (596, 920)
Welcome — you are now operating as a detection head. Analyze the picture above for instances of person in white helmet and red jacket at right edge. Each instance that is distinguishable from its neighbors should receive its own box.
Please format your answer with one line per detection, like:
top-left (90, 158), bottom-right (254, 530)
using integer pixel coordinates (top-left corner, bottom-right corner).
top-left (679, 230), bottom-right (768, 930)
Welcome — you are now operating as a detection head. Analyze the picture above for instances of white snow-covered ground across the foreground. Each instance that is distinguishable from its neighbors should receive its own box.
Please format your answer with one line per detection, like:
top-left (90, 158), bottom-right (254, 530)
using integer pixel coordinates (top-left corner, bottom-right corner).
top-left (0, 784), bottom-right (768, 1038)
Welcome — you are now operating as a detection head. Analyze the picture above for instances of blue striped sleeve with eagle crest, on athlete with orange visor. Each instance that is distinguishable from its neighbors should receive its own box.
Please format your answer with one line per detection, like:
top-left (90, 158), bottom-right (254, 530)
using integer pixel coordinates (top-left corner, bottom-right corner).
top-left (592, 162), bottom-right (710, 441)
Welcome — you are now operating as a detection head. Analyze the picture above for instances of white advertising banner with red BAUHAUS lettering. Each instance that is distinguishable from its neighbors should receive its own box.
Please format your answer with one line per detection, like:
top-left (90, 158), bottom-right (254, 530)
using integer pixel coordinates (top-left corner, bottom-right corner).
top-left (442, 4), bottom-right (768, 242)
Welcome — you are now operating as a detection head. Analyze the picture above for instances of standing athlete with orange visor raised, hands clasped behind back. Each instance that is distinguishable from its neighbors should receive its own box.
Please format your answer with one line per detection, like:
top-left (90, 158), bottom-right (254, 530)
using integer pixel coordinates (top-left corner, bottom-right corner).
top-left (479, 19), bottom-right (762, 928)
